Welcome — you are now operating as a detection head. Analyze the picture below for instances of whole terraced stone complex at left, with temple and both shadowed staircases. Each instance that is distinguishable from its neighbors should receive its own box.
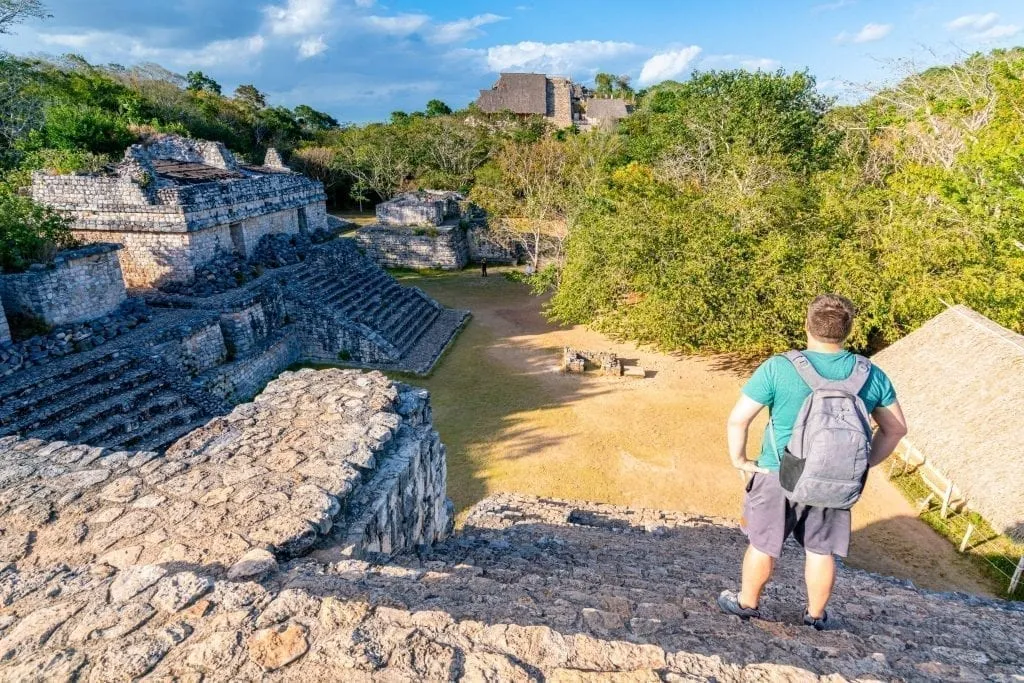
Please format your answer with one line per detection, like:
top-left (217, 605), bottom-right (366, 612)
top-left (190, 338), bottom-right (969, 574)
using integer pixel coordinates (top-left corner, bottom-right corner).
top-left (0, 137), bottom-right (468, 451)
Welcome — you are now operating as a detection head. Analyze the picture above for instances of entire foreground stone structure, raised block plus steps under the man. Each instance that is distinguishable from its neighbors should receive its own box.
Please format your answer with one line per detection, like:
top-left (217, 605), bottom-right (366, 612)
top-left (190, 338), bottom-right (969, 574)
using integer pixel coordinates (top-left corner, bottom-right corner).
top-left (0, 403), bottom-right (1024, 682)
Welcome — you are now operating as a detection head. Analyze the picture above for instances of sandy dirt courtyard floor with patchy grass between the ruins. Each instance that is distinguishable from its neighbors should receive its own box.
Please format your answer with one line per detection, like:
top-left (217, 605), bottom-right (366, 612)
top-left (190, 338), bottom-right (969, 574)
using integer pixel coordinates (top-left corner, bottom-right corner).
top-left (389, 269), bottom-right (992, 594)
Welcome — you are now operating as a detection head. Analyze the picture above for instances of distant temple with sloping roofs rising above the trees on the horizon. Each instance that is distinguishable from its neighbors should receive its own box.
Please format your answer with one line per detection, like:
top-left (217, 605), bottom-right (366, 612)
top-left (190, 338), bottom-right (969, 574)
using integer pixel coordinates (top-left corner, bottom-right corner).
top-left (476, 74), bottom-right (633, 130)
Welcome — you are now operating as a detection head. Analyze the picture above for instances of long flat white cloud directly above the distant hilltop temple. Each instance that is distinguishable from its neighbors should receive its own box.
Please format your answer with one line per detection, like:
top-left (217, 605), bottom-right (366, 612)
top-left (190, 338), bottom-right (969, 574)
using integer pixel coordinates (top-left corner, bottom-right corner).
top-left (486, 40), bottom-right (641, 75)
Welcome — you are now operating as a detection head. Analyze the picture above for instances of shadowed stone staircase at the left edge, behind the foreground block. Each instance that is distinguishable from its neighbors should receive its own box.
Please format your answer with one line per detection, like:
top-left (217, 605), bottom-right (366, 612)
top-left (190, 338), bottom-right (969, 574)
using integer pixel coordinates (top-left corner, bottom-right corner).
top-left (0, 345), bottom-right (209, 451)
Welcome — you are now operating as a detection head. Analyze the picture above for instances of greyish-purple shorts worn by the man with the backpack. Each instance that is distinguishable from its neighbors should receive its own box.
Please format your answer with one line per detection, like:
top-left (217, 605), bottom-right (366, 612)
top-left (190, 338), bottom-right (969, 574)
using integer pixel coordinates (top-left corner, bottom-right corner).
top-left (740, 472), bottom-right (850, 558)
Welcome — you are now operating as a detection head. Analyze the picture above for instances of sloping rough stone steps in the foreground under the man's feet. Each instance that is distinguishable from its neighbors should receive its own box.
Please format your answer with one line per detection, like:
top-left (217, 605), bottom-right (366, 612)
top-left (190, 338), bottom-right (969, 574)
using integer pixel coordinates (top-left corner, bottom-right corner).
top-left (0, 495), bottom-right (1024, 682)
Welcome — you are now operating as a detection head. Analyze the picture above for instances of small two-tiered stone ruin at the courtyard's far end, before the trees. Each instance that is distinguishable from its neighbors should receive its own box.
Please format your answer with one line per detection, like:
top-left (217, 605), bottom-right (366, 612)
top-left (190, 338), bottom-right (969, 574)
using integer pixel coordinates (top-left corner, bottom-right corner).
top-left (356, 189), bottom-right (518, 270)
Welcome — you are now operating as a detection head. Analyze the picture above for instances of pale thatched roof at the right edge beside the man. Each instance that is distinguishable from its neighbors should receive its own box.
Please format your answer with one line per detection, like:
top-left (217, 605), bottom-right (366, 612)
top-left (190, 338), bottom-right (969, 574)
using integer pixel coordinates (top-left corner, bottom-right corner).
top-left (872, 306), bottom-right (1024, 541)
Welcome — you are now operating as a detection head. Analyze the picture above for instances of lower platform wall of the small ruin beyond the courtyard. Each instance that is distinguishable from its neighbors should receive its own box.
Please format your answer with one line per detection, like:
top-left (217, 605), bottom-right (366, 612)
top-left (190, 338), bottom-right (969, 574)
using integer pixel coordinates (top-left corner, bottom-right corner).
top-left (355, 224), bottom-right (469, 270)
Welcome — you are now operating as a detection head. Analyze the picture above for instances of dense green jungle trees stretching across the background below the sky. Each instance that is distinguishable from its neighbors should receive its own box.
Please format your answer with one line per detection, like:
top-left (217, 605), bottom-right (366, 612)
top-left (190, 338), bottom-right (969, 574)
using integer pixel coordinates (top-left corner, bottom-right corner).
top-left (0, 50), bottom-right (1024, 354)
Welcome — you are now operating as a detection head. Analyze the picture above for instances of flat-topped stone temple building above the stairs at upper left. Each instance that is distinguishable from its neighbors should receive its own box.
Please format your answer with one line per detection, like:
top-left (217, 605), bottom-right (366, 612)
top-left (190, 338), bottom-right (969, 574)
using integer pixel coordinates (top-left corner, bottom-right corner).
top-left (32, 135), bottom-right (327, 288)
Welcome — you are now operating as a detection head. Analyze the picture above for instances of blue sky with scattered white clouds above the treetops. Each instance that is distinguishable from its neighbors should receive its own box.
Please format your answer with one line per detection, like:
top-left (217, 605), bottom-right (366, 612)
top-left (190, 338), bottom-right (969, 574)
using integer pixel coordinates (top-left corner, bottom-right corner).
top-left (0, 0), bottom-right (1024, 122)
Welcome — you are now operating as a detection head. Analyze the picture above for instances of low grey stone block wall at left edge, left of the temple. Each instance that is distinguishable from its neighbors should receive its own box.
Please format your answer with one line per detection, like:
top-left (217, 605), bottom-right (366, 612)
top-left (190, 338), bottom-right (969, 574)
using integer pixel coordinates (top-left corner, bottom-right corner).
top-left (0, 244), bottom-right (127, 326)
